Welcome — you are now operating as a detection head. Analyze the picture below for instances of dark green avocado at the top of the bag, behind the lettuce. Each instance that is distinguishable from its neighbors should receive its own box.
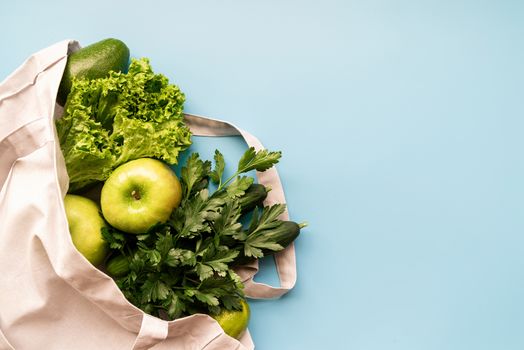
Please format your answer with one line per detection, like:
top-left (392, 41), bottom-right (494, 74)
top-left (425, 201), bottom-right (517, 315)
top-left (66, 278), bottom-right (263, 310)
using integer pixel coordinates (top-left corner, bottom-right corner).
top-left (57, 38), bottom-right (129, 106)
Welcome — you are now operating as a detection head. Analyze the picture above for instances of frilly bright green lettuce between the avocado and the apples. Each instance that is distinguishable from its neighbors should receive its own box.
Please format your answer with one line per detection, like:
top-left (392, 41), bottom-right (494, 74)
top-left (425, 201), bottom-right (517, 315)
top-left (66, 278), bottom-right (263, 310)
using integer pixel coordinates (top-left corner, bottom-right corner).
top-left (56, 58), bottom-right (191, 191)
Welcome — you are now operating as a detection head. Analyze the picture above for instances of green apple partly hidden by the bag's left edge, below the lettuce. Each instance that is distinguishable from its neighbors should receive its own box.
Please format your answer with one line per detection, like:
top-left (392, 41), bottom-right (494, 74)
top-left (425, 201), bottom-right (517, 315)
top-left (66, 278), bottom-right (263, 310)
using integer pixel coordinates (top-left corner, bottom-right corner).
top-left (64, 194), bottom-right (107, 265)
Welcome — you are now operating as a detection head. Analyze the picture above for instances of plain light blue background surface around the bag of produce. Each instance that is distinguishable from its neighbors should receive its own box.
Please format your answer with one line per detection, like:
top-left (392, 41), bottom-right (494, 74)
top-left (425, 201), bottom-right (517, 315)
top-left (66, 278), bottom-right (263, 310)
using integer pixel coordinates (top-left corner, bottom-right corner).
top-left (0, 0), bottom-right (524, 350)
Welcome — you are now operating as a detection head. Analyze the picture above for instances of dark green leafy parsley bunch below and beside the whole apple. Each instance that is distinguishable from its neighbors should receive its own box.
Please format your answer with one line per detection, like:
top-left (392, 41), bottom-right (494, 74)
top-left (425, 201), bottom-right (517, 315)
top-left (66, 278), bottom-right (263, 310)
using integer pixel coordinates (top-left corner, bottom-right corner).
top-left (103, 148), bottom-right (294, 319)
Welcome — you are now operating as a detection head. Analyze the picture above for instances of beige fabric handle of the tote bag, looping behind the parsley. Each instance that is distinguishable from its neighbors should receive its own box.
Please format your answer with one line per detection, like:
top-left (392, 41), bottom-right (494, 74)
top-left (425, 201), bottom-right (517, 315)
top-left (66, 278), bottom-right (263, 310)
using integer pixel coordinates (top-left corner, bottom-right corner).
top-left (184, 114), bottom-right (297, 299)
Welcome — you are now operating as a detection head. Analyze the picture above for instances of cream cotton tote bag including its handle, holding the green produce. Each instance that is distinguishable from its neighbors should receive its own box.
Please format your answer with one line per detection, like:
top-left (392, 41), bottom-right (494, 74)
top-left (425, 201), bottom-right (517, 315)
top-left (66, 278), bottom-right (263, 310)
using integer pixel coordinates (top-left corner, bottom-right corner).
top-left (0, 41), bottom-right (296, 350)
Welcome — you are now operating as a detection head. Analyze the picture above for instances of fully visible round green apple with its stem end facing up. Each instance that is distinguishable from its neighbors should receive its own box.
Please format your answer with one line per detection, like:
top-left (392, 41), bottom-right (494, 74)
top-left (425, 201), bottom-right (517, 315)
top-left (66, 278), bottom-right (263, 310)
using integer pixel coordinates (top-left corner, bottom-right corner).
top-left (100, 158), bottom-right (182, 234)
